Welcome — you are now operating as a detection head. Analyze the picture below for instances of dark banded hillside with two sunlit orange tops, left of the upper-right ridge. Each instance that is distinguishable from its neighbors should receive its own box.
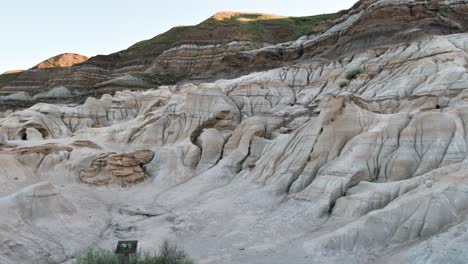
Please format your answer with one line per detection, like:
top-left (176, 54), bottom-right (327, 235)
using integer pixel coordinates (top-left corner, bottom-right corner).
top-left (0, 12), bottom-right (337, 100)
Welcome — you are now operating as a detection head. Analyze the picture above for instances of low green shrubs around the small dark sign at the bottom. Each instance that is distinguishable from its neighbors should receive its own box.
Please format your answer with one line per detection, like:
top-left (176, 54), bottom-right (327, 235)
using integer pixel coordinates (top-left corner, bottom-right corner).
top-left (77, 241), bottom-right (193, 264)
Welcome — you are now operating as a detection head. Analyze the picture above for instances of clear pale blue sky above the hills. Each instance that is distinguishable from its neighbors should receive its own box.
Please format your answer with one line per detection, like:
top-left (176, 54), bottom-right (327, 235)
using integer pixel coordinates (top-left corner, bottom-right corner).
top-left (0, 0), bottom-right (357, 73)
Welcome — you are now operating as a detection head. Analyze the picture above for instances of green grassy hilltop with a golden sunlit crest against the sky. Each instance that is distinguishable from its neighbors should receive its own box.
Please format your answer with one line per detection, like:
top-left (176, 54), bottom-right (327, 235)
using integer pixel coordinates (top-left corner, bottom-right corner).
top-left (128, 13), bottom-right (336, 51)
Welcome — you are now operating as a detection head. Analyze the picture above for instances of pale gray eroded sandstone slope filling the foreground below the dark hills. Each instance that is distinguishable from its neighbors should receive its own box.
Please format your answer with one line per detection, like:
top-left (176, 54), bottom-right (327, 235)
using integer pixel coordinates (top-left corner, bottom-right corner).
top-left (0, 1), bottom-right (468, 264)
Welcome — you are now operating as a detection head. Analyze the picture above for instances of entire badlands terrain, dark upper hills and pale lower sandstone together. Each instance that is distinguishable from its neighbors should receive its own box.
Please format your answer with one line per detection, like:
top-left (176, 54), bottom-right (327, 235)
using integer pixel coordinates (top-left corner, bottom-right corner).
top-left (0, 0), bottom-right (468, 264)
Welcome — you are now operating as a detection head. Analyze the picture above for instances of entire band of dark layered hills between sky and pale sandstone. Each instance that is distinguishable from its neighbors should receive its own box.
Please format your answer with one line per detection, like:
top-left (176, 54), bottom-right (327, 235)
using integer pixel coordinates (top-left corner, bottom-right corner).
top-left (0, 0), bottom-right (468, 110)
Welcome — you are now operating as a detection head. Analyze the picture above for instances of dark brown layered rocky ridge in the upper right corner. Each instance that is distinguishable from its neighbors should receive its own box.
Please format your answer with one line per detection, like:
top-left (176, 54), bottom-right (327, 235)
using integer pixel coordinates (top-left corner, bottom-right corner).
top-left (223, 0), bottom-right (468, 75)
